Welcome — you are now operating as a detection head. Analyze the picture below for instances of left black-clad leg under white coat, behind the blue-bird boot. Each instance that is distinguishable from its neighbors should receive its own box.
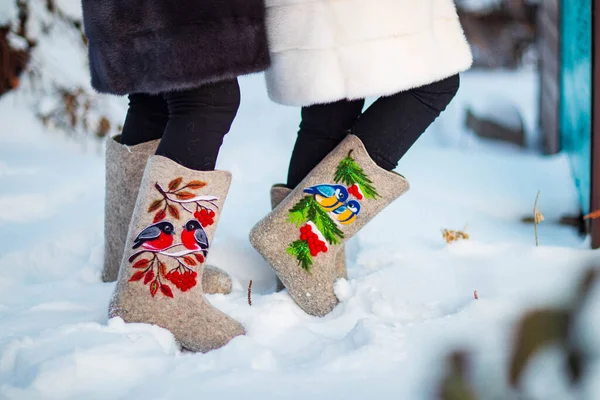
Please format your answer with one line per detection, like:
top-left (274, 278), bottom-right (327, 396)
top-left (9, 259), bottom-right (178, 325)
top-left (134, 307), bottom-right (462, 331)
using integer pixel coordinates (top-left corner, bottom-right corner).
top-left (287, 100), bottom-right (365, 189)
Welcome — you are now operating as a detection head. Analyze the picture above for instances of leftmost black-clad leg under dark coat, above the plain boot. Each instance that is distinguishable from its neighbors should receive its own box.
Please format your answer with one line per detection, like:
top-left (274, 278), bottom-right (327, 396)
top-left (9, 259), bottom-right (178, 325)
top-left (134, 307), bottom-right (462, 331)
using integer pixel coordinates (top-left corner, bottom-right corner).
top-left (120, 94), bottom-right (169, 146)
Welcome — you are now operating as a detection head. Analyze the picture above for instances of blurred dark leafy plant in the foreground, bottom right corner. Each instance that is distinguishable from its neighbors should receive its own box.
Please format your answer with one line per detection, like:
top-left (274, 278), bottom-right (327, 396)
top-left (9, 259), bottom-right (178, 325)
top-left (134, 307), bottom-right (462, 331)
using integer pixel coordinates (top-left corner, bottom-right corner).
top-left (439, 269), bottom-right (600, 400)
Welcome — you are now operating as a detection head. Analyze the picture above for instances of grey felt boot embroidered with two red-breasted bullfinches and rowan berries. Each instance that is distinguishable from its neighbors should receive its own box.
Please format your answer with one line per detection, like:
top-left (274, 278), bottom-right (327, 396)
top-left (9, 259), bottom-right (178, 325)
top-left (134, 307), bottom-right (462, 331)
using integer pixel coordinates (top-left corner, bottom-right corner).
top-left (109, 156), bottom-right (244, 352)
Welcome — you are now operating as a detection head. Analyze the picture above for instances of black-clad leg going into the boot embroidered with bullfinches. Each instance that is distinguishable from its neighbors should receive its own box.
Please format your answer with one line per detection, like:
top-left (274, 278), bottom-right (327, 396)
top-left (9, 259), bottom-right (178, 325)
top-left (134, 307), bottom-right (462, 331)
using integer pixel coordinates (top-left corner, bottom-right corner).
top-left (156, 79), bottom-right (240, 171)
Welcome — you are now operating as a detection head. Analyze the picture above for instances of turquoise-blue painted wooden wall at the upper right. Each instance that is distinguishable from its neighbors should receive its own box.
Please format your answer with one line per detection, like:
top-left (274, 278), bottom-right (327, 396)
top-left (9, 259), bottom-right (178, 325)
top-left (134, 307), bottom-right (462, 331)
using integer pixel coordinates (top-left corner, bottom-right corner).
top-left (560, 0), bottom-right (592, 214)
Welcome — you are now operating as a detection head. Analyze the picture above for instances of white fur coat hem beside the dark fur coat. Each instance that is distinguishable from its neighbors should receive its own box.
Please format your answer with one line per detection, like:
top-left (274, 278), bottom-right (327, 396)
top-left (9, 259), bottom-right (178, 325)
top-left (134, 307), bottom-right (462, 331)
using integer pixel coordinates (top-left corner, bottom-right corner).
top-left (266, 0), bottom-right (472, 106)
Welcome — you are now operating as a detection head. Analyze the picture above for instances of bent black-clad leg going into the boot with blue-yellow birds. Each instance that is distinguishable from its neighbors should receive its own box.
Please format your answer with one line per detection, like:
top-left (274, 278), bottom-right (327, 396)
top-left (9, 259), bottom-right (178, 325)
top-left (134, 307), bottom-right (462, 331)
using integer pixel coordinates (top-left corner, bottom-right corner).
top-left (352, 75), bottom-right (460, 171)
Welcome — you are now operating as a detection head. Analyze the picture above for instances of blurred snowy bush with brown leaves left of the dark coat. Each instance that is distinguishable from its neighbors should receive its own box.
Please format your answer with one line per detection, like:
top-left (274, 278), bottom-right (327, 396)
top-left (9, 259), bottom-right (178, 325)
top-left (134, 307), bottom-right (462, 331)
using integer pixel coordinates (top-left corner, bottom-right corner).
top-left (0, 0), bottom-right (123, 141)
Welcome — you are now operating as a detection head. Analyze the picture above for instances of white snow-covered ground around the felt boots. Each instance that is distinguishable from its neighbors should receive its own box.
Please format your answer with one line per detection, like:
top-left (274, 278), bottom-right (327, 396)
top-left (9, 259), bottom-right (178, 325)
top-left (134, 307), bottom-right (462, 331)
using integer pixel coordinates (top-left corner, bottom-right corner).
top-left (0, 67), bottom-right (600, 400)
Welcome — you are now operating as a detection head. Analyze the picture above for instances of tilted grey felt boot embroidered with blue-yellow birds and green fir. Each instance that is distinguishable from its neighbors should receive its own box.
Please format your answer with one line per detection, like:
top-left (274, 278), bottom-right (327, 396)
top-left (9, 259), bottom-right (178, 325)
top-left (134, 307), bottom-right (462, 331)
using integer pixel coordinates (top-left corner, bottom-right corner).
top-left (250, 135), bottom-right (408, 316)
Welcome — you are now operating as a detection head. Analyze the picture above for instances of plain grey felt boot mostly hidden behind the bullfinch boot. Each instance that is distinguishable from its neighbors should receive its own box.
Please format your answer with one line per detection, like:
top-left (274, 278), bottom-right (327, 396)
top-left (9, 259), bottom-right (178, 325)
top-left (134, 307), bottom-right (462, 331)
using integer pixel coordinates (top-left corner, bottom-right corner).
top-left (102, 136), bottom-right (232, 294)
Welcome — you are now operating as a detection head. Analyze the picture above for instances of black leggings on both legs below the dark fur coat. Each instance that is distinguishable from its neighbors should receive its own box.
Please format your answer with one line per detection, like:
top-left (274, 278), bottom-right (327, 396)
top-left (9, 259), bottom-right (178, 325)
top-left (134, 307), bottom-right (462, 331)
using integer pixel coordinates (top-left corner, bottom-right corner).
top-left (121, 79), bottom-right (240, 171)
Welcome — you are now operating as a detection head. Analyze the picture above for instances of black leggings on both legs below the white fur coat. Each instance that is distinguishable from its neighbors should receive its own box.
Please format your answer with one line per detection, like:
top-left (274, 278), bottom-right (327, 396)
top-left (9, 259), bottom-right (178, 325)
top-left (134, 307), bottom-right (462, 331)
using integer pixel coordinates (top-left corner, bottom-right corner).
top-left (287, 75), bottom-right (460, 188)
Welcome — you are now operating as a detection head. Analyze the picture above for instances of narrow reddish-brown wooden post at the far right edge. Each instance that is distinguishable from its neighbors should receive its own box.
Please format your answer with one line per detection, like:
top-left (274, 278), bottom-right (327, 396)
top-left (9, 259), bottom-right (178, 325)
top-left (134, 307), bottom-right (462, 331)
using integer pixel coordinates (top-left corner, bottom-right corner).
top-left (590, 0), bottom-right (600, 249)
